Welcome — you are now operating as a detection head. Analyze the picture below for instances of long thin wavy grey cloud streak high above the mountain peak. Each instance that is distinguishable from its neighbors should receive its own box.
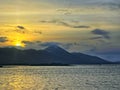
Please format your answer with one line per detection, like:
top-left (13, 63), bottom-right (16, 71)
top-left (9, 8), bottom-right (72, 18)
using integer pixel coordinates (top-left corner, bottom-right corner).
top-left (40, 20), bottom-right (90, 28)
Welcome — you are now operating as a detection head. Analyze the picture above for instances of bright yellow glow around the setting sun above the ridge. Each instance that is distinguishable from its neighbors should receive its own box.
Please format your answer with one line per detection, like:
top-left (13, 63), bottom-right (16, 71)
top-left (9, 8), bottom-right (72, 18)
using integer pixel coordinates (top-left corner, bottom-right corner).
top-left (1, 31), bottom-right (35, 48)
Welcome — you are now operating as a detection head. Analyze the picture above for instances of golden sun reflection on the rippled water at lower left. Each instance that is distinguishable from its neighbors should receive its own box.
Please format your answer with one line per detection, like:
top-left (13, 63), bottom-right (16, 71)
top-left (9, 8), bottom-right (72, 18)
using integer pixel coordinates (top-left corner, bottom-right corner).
top-left (0, 70), bottom-right (45, 90)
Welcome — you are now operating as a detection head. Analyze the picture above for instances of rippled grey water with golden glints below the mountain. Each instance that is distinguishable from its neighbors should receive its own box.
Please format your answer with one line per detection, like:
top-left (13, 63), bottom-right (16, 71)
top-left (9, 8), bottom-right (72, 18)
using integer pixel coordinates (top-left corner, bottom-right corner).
top-left (0, 65), bottom-right (120, 90)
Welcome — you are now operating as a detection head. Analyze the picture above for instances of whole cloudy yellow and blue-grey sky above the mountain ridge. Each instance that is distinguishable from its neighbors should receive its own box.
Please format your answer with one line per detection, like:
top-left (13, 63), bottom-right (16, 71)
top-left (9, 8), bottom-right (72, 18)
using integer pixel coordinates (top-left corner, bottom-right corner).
top-left (0, 0), bottom-right (120, 61)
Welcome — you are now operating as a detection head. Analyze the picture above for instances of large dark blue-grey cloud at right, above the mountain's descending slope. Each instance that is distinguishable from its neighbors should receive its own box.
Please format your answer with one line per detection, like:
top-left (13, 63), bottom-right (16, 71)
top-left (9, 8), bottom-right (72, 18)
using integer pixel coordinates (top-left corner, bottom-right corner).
top-left (91, 29), bottom-right (110, 39)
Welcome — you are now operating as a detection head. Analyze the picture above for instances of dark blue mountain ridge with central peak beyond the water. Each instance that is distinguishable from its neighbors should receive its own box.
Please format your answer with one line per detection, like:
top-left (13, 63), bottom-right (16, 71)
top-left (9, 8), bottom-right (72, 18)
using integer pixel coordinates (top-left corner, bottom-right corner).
top-left (0, 45), bottom-right (111, 65)
